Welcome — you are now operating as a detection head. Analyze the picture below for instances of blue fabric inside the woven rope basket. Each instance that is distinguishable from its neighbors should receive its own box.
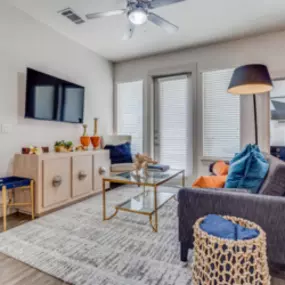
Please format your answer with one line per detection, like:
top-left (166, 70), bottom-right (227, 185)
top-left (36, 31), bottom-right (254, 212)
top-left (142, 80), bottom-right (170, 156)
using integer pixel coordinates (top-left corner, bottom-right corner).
top-left (200, 215), bottom-right (259, 240)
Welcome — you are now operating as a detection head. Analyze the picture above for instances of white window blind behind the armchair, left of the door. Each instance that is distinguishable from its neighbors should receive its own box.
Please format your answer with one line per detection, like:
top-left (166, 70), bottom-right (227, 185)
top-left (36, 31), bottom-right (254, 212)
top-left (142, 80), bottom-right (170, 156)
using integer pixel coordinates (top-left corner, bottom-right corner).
top-left (117, 81), bottom-right (143, 154)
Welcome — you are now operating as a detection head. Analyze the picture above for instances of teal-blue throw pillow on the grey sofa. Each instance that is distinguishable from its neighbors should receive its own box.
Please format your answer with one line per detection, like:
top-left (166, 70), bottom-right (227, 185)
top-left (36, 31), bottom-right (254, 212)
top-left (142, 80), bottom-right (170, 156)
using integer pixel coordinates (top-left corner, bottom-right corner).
top-left (225, 145), bottom-right (269, 193)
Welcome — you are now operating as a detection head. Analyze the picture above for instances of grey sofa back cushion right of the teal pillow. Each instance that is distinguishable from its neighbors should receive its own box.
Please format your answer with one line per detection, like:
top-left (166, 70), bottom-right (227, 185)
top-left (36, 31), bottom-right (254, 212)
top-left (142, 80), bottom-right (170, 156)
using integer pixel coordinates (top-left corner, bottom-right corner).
top-left (259, 154), bottom-right (285, 196)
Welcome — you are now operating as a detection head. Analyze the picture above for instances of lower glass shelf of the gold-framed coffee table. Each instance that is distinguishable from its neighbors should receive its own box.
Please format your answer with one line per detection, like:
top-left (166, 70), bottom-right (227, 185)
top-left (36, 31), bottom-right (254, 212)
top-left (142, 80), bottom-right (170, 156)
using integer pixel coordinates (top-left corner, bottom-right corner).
top-left (116, 191), bottom-right (175, 215)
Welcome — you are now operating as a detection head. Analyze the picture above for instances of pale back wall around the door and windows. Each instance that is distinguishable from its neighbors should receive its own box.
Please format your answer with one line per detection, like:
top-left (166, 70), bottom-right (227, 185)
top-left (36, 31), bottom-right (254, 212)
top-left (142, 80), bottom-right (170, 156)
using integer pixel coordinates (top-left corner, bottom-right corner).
top-left (114, 32), bottom-right (285, 178)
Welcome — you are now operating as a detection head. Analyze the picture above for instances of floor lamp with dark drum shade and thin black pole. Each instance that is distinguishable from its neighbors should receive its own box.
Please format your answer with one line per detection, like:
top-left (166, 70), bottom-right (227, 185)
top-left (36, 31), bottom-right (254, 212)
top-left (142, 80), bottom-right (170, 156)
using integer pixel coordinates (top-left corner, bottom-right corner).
top-left (228, 64), bottom-right (273, 145)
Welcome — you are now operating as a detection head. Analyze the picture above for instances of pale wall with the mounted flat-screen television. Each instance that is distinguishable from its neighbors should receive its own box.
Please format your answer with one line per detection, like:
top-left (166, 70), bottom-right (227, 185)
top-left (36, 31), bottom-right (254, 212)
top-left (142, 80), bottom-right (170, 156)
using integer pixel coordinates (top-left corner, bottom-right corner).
top-left (0, 3), bottom-right (113, 176)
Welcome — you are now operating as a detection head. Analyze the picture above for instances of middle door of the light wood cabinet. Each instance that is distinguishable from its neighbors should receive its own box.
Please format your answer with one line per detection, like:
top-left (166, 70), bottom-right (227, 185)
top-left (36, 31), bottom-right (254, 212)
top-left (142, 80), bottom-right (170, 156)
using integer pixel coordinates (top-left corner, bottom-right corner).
top-left (72, 155), bottom-right (93, 197)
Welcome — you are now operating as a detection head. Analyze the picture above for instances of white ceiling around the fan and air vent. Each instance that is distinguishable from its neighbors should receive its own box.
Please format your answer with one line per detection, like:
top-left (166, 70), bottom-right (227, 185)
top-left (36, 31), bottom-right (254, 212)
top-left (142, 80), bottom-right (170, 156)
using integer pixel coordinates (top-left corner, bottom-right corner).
top-left (6, 0), bottom-right (285, 61)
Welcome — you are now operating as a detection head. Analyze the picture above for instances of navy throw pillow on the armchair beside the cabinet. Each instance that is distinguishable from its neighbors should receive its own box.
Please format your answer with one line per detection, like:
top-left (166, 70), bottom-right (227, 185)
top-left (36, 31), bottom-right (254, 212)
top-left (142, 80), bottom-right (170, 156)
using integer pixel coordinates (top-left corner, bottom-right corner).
top-left (104, 142), bottom-right (133, 164)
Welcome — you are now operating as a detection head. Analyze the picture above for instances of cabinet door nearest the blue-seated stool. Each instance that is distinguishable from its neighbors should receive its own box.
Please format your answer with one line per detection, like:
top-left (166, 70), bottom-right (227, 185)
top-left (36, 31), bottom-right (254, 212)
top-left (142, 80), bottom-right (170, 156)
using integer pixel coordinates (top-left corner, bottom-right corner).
top-left (43, 158), bottom-right (71, 207)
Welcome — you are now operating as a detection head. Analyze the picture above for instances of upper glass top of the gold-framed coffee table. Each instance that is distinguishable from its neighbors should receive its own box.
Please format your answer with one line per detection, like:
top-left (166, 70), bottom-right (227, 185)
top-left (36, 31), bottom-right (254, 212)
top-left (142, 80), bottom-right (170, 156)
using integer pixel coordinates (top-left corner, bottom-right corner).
top-left (104, 169), bottom-right (184, 186)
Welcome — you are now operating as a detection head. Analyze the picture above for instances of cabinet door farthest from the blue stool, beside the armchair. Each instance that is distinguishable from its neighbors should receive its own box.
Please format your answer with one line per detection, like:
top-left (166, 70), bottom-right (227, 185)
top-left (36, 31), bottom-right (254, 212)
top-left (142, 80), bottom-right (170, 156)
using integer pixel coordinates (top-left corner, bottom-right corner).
top-left (93, 151), bottom-right (111, 192)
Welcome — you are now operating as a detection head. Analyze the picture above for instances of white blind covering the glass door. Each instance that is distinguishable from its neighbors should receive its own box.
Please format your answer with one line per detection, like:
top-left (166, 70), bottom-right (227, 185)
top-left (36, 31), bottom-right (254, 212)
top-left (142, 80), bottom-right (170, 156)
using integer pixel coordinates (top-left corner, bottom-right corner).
top-left (155, 75), bottom-right (192, 173)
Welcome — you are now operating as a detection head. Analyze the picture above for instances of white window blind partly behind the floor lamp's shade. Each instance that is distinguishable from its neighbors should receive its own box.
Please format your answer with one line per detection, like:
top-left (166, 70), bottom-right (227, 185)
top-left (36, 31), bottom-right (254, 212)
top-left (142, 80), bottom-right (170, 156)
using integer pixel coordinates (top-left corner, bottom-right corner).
top-left (202, 69), bottom-right (240, 158)
